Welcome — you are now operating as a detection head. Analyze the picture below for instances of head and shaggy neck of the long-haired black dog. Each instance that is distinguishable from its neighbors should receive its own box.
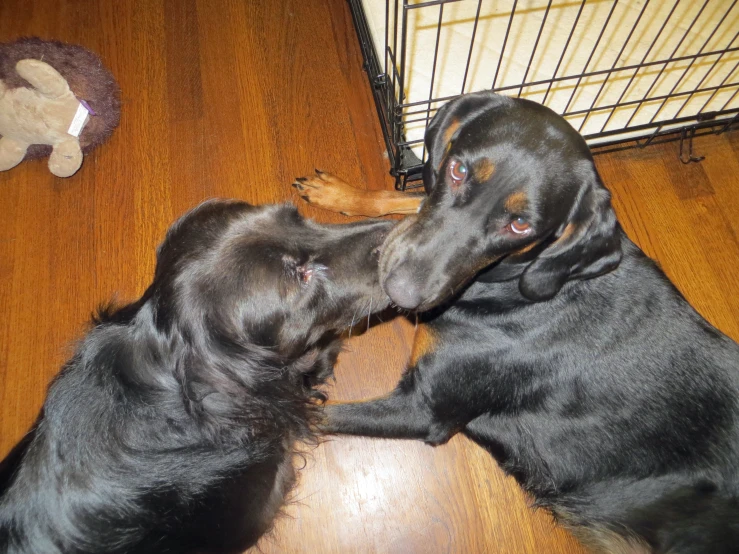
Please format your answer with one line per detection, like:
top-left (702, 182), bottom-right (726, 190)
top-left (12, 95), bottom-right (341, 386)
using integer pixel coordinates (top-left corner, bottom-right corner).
top-left (91, 201), bottom-right (392, 441)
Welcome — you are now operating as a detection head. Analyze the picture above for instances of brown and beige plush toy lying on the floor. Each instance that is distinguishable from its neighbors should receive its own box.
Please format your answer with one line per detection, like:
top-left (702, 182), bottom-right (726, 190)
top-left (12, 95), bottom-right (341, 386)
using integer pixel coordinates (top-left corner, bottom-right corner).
top-left (0, 38), bottom-right (120, 177)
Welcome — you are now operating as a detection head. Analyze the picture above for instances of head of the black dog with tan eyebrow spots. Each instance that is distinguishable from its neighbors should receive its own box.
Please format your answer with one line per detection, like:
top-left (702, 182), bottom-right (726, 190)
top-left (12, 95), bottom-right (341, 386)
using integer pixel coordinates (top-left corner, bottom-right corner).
top-left (380, 92), bottom-right (621, 310)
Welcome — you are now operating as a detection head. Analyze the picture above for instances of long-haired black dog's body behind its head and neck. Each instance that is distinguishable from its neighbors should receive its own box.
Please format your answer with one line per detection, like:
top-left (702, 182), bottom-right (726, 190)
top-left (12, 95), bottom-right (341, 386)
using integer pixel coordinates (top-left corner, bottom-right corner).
top-left (0, 306), bottom-right (294, 554)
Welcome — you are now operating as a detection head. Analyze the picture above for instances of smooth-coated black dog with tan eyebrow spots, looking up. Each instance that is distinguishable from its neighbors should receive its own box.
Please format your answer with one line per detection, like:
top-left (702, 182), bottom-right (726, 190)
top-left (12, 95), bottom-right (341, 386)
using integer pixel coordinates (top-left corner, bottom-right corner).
top-left (296, 93), bottom-right (739, 554)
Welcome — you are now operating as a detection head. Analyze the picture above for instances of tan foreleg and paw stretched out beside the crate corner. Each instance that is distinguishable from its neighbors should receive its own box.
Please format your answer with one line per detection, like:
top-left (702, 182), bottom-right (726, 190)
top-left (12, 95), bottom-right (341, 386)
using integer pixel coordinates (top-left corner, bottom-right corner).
top-left (293, 170), bottom-right (425, 217)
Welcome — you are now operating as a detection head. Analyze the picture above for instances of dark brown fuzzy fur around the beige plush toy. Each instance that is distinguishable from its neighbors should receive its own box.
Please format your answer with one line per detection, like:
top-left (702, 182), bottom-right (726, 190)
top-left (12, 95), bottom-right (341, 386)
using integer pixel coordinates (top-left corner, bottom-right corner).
top-left (0, 37), bottom-right (121, 160)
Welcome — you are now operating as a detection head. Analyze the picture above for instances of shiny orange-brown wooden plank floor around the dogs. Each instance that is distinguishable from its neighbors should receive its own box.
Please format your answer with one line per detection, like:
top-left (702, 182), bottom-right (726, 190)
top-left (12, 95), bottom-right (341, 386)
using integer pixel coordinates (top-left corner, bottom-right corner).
top-left (0, 0), bottom-right (739, 554)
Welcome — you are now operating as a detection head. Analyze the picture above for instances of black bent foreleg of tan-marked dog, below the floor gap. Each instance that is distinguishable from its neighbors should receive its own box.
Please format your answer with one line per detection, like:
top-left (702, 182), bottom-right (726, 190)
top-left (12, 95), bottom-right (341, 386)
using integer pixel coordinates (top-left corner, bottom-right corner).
top-left (321, 388), bottom-right (461, 445)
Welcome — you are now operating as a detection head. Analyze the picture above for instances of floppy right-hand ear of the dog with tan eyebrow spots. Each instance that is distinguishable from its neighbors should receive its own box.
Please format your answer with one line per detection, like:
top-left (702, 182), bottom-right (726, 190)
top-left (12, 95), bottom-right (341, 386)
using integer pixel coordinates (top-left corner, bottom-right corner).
top-left (519, 174), bottom-right (621, 301)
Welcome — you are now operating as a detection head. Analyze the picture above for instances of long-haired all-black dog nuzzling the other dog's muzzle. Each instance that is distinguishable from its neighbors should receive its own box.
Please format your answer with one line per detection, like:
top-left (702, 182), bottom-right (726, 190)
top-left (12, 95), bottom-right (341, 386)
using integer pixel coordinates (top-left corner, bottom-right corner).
top-left (0, 201), bottom-right (390, 554)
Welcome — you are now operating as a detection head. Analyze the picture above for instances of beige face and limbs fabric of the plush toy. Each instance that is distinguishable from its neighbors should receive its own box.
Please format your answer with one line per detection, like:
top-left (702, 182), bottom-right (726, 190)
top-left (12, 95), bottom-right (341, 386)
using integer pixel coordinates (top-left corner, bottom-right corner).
top-left (0, 60), bottom-right (88, 177)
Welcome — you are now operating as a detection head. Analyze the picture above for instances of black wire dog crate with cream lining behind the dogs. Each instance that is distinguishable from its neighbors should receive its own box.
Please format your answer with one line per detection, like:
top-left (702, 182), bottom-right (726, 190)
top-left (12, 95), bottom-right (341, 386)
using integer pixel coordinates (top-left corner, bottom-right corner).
top-left (349, 0), bottom-right (739, 190)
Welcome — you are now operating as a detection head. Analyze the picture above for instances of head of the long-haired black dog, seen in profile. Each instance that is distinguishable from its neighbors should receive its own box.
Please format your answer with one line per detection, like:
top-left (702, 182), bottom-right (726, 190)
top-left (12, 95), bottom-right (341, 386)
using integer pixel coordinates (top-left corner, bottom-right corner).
top-left (149, 201), bottom-right (391, 359)
